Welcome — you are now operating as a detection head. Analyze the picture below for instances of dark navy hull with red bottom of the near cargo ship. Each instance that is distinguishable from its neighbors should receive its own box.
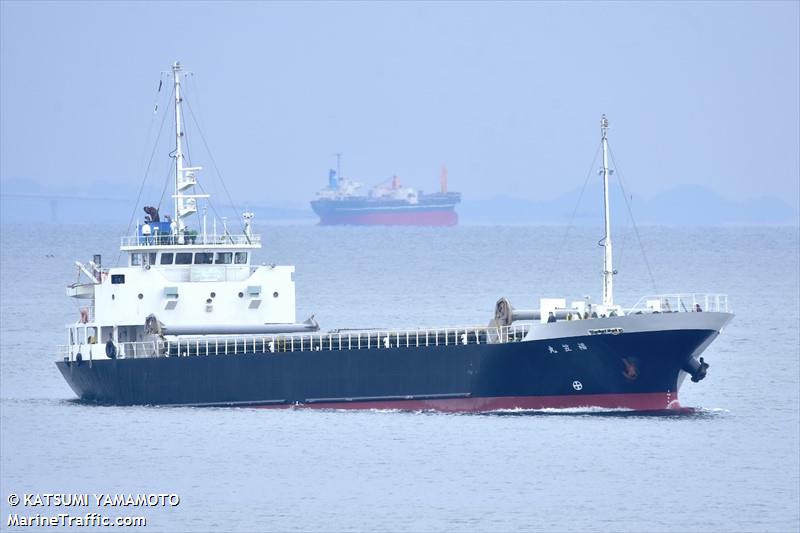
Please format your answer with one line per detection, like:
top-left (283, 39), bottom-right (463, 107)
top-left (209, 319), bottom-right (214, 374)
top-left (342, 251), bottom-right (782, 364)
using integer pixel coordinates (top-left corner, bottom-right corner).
top-left (57, 330), bottom-right (717, 411)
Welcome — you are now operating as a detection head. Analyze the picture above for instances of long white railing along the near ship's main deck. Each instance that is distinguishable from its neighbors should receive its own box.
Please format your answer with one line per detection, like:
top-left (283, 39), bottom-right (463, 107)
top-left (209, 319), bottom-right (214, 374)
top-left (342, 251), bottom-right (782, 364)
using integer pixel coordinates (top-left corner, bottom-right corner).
top-left (58, 324), bottom-right (530, 361)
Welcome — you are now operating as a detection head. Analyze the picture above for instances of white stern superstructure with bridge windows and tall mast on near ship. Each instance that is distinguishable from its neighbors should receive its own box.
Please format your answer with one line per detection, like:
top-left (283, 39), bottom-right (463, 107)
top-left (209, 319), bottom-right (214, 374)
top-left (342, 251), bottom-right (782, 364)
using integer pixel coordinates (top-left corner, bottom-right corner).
top-left (67, 62), bottom-right (318, 359)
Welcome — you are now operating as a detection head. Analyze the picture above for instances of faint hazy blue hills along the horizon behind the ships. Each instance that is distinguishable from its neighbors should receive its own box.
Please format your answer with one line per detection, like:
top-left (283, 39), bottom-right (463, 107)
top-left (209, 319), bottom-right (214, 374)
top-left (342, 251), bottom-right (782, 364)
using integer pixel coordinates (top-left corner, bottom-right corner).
top-left (0, 180), bottom-right (800, 226)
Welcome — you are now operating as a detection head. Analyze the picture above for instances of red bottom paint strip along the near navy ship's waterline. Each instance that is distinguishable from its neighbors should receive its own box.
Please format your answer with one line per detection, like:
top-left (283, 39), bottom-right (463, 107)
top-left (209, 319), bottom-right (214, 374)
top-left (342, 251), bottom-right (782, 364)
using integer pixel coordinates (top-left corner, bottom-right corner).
top-left (255, 392), bottom-right (682, 413)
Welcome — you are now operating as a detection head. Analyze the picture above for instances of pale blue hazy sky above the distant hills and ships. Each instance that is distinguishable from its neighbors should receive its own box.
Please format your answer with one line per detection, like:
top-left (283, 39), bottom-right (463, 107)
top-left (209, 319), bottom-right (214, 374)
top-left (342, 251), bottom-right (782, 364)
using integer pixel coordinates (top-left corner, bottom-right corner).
top-left (0, 0), bottom-right (800, 207)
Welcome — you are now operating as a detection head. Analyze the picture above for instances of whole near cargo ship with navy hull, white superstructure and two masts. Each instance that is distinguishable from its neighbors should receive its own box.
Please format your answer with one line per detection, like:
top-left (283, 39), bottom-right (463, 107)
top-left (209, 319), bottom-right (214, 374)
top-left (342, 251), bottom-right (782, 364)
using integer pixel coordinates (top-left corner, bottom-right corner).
top-left (56, 62), bottom-right (733, 412)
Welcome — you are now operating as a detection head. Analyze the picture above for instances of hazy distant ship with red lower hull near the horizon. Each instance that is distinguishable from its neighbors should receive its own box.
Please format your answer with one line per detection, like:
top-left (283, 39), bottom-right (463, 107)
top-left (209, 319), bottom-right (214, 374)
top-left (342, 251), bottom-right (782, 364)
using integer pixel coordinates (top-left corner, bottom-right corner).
top-left (311, 168), bottom-right (461, 226)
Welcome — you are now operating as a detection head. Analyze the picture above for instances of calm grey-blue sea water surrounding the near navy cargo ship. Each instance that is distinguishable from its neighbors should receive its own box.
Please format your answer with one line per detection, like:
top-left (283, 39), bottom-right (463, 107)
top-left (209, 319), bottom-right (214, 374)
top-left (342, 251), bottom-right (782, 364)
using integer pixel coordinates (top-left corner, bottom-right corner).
top-left (0, 225), bottom-right (800, 531)
